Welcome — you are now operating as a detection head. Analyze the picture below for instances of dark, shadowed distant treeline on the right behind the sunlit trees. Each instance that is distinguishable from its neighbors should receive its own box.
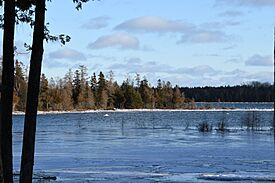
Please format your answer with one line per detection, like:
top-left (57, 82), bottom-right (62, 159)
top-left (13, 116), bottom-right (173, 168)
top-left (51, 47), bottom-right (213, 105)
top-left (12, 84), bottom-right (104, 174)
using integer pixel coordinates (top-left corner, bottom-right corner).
top-left (180, 81), bottom-right (274, 102)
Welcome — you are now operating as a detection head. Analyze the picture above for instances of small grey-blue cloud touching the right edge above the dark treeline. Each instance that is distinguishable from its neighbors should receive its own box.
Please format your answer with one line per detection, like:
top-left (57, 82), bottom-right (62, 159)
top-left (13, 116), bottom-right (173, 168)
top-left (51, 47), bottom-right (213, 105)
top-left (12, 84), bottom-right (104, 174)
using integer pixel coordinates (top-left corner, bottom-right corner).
top-left (245, 54), bottom-right (273, 66)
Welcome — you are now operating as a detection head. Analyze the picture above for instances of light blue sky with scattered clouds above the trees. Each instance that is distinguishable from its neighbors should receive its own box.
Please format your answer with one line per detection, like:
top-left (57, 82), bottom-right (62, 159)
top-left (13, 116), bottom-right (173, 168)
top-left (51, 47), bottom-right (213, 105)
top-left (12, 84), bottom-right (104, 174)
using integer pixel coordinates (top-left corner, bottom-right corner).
top-left (13, 0), bottom-right (275, 87)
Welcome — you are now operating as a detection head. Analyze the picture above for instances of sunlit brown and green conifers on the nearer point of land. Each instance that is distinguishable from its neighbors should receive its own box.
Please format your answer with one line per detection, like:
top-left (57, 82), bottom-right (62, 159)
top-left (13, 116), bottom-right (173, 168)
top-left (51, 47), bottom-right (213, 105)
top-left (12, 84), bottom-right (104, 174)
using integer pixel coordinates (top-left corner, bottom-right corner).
top-left (9, 61), bottom-right (195, 111)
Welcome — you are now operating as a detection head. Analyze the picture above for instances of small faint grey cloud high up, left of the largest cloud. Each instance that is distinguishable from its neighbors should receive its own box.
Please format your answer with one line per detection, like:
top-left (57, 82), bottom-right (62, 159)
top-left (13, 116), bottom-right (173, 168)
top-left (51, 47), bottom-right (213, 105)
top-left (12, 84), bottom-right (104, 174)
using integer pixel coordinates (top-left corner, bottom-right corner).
top-left (81, 16), bottom-right (110, 29)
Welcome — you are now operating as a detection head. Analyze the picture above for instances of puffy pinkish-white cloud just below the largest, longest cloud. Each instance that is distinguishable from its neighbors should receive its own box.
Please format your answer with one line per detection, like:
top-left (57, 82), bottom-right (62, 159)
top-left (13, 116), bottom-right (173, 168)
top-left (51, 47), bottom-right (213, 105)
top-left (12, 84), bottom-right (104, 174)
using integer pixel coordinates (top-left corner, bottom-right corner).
top-left (88, 33), bottom-right (140, 50)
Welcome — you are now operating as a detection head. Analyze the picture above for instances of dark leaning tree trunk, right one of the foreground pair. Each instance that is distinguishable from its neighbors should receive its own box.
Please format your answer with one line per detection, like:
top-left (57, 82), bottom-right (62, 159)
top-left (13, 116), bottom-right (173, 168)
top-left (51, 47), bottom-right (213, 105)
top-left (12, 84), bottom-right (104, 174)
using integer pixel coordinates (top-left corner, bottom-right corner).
top-left (20, 0), bottom-right (46, 183)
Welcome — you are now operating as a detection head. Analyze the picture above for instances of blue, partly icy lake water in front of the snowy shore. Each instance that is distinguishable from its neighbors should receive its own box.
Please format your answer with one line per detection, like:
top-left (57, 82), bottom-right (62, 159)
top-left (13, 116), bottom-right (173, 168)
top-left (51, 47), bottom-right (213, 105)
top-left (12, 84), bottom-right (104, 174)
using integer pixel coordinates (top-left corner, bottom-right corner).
top-left (13, 103), bottom-right (275, 183)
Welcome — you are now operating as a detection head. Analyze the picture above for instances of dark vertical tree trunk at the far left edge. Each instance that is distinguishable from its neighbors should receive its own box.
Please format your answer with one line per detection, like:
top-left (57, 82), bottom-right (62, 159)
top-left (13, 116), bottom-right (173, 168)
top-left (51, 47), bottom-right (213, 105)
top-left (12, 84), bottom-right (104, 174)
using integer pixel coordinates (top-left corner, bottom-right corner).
top-left (0, 0), bottom-right (15, 183)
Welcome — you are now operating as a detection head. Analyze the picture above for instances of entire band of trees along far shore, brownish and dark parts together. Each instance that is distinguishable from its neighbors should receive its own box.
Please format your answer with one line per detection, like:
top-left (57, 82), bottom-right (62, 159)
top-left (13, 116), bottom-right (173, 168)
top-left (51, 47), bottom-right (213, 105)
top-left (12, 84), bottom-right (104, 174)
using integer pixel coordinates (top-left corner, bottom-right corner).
top-left (0, 61), bottom-right (273, 111)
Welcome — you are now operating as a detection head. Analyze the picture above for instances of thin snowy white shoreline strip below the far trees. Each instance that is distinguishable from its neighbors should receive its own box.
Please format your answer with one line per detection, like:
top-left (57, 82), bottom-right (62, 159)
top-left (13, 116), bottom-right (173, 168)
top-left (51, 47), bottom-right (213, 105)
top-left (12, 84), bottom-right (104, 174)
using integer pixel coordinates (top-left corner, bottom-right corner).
top-left (13, 108), bottom-right (274, 115)
